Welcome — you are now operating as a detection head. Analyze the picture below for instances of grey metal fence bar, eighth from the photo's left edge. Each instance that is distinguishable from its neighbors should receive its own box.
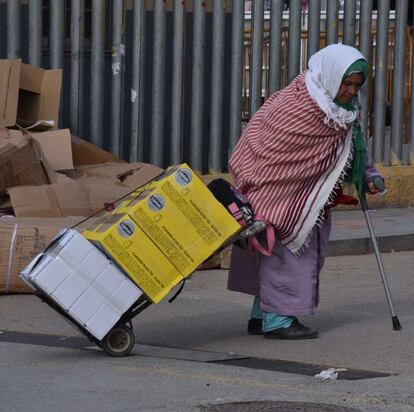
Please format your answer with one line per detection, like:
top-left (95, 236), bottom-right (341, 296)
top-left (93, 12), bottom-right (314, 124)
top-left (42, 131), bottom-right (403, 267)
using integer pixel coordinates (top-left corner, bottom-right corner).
top-left (150, 0), bottom-right (167, 166)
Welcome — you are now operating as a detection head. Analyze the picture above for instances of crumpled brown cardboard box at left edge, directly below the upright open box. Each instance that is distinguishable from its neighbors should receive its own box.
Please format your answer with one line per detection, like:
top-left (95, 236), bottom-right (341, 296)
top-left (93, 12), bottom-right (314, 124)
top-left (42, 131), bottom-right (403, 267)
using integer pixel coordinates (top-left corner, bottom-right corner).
top-left (0, 127), bottom-right (49, 194)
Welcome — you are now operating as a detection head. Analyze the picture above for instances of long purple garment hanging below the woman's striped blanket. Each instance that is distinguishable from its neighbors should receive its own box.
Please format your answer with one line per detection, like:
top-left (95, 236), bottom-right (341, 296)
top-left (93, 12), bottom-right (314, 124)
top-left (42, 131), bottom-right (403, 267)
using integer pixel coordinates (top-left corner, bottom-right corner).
top-left (228, 213), bottom-right (331, 316)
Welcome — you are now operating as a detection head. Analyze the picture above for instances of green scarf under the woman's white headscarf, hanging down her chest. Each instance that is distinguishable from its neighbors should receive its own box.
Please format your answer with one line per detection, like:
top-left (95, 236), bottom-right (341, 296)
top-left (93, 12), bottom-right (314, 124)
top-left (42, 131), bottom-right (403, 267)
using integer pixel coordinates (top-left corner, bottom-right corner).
top-left (335, 59), bottom-right (368, 197)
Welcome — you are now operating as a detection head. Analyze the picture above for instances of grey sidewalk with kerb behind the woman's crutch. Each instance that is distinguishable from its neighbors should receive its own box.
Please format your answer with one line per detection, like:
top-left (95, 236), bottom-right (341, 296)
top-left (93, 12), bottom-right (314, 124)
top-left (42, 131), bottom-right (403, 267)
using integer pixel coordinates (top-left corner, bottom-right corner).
top-left (329, 208), bottom-right (414, 256)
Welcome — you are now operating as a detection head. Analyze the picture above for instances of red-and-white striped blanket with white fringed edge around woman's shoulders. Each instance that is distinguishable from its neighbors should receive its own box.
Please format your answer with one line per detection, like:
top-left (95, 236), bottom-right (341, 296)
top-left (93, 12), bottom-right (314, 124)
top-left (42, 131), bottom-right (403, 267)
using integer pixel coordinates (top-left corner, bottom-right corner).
top-left (229, 73), bottom-right (352, 254)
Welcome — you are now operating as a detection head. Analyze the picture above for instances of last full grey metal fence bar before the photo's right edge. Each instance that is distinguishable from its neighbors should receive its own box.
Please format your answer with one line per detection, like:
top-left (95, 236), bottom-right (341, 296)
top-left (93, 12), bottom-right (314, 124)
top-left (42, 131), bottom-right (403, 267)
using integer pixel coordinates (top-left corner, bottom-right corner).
top-left (391, 0), bottom-right (408, 165)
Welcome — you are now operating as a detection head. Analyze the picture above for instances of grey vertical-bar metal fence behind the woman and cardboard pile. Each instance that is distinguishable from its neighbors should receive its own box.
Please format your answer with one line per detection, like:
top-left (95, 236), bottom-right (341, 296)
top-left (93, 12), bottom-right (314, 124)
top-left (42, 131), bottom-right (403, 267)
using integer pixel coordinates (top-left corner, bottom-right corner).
top-left (0, 0), bottom-right (414, 173)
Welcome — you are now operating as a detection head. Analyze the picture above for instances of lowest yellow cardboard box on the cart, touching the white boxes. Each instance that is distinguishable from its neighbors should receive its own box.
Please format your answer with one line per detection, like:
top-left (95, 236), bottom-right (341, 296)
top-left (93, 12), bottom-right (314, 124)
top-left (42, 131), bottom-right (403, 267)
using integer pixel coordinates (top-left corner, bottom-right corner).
top-left (82, 214), bottom-right (183, 303)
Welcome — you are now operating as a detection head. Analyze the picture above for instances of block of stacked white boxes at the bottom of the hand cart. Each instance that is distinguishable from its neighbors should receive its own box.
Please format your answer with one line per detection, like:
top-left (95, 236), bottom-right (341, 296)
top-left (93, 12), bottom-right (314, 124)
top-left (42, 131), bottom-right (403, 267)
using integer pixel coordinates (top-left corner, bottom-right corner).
top-left (21, 230), bottom-right (142, 340)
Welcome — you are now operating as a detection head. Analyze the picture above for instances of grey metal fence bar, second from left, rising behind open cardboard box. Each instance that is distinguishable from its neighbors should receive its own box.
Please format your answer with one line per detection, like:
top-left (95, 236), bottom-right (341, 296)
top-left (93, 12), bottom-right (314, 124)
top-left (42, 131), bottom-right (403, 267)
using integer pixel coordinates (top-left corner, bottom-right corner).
top-left (28, 0), bottom-right (43, 67)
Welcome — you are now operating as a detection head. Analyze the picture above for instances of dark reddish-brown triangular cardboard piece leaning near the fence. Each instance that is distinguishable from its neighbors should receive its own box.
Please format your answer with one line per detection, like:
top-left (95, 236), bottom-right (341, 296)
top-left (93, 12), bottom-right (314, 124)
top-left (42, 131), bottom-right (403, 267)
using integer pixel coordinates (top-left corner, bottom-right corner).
top-left (71, 135), bottom-right (126, 166)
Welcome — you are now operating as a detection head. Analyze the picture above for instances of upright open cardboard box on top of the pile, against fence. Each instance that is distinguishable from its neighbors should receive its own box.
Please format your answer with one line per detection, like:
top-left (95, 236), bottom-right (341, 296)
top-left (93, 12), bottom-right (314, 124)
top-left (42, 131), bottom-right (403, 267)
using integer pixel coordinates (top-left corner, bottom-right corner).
top-left (0, 59), bottom-right (62, 128)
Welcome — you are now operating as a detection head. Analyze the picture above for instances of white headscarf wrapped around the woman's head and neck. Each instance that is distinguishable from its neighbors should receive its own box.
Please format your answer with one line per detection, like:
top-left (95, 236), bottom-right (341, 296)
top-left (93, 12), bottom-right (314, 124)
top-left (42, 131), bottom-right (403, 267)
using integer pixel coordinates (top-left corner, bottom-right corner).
top-left (305, 44), bottom-right (365, 129)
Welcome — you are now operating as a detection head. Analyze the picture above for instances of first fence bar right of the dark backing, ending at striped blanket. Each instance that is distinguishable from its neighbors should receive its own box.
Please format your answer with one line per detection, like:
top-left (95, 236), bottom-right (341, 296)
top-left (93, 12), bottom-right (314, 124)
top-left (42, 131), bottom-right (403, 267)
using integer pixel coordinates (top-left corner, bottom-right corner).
top-left (249, 0), bottom-right (264, 118)
